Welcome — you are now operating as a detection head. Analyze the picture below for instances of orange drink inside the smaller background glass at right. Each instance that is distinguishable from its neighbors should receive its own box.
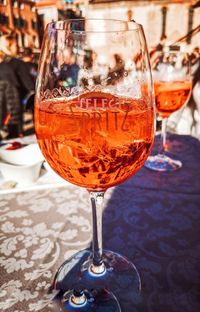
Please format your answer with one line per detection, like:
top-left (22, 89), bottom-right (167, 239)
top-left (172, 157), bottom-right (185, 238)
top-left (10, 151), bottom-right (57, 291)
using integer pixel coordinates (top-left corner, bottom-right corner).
top-left (154, 81), bottom-right (192, 118)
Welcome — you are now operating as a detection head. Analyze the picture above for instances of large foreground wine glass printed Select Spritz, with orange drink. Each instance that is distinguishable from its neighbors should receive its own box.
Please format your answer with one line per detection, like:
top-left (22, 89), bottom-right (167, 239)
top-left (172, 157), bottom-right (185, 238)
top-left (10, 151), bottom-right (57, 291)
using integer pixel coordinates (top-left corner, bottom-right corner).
top-left (35, 19), bottom-right (154, 312)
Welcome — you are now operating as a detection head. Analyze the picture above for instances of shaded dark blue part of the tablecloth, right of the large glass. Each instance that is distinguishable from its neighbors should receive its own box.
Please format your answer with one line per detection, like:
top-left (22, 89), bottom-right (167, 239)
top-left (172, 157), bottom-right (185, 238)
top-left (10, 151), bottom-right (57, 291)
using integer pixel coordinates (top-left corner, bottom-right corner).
top-left (104, 135), bottom-right (200, 312)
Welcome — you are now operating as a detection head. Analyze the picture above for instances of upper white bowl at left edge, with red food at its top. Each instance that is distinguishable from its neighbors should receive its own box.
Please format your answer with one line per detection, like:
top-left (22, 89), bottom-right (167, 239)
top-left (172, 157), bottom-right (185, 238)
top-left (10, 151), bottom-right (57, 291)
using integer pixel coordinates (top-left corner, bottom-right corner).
top-left (0, 143), bottom-right (44, 165)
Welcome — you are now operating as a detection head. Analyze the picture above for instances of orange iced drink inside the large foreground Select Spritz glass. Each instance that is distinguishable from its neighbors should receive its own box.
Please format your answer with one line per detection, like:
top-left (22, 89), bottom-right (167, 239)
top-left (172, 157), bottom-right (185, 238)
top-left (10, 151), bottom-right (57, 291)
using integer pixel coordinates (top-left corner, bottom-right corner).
top-left (35, 92), bottom-right (154, 190)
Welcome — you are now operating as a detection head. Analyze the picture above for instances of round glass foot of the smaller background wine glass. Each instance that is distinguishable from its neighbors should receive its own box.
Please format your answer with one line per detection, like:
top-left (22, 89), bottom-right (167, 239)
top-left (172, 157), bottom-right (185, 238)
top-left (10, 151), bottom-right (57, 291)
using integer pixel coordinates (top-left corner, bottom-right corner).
top-left (145, 154), bottom-right (182, 172)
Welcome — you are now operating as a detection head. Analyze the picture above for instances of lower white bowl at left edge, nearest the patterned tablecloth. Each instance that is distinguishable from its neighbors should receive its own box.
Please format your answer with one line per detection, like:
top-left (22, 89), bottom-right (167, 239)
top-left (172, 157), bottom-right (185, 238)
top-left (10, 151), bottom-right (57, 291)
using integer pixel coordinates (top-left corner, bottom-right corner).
top-left (0, 161), bottom-right (43, 186)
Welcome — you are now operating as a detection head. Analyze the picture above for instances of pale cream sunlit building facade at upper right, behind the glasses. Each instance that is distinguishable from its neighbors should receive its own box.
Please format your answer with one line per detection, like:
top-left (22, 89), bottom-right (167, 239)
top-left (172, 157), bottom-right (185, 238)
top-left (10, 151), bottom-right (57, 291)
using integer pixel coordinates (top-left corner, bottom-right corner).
top-left (83, 0), bottom-right (200, 46)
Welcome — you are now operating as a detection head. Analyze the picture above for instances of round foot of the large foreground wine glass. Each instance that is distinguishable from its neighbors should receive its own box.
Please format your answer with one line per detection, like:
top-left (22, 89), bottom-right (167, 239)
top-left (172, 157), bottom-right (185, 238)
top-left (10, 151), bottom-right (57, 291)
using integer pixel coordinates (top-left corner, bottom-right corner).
top-left (53, 250), bottom-right (141, 312)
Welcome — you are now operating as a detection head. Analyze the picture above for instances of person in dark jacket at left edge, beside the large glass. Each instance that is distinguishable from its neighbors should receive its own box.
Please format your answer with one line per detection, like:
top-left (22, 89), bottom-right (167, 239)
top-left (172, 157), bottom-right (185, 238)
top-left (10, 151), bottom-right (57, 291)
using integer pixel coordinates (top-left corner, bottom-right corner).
top-left (0, 34), bottom-right (35, 137)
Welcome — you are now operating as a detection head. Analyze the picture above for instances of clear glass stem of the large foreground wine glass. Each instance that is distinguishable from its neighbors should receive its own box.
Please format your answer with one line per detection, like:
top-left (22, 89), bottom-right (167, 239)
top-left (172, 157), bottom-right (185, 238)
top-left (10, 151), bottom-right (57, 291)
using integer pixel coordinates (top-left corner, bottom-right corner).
top-left (90, 192), bottom-right (104, 267)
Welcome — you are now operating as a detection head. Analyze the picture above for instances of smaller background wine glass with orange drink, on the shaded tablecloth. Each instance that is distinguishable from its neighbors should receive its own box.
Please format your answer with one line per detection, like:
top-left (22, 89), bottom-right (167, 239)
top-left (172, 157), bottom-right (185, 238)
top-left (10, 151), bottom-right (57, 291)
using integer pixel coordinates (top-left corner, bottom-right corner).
top-left (145, 46), bottom-right (192, 172)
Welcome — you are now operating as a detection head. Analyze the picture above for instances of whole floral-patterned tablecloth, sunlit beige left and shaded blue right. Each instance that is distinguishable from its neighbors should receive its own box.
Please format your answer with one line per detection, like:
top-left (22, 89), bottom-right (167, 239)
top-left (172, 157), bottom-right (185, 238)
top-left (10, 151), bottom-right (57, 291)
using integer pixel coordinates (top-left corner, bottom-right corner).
top-left (0, 135), bottom-right (200, 312)
